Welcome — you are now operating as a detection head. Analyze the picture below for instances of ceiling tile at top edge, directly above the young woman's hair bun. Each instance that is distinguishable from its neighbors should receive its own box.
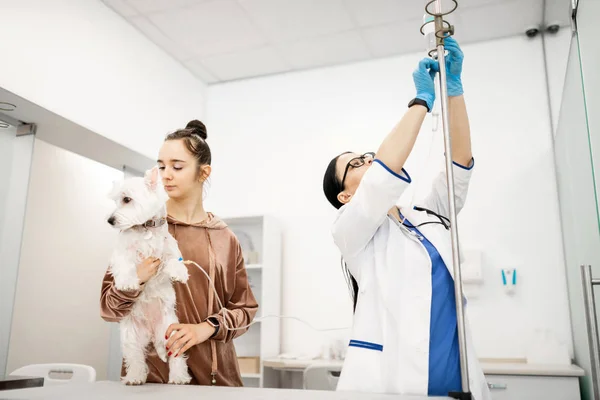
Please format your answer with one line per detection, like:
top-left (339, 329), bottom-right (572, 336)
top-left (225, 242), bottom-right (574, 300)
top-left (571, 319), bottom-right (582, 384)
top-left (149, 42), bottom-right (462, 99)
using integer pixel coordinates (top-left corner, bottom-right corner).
top-left (148, 1), bottom-right (266, 56)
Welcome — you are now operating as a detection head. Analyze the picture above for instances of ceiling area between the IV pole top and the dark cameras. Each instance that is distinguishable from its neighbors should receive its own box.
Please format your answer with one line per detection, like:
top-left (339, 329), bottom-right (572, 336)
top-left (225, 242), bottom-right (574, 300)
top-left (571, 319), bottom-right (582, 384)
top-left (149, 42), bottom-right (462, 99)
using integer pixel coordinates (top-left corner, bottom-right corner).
top-left (456, 0), bottom-right (543, 42)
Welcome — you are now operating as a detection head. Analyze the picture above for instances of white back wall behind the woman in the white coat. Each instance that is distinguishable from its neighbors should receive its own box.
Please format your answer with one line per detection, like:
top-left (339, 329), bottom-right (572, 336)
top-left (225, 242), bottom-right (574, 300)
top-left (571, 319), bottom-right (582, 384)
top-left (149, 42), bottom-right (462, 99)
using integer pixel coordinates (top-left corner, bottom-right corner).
top-left (207, 37), bottom-right (572, 358)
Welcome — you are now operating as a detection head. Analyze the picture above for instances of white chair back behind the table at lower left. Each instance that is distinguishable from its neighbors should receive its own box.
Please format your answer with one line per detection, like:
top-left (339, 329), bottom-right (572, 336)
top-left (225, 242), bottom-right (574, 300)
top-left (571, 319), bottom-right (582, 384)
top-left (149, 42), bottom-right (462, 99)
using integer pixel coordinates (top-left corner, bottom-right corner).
top-left (10, 364), bottom-right (96, 386)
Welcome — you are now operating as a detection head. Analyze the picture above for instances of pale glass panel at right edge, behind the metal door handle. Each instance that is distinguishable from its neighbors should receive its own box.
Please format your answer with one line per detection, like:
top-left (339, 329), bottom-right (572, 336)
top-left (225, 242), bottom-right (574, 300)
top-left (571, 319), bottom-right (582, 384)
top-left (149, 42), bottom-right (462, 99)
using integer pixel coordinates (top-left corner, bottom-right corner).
top-left (554, 25), bottom-right (600, 399)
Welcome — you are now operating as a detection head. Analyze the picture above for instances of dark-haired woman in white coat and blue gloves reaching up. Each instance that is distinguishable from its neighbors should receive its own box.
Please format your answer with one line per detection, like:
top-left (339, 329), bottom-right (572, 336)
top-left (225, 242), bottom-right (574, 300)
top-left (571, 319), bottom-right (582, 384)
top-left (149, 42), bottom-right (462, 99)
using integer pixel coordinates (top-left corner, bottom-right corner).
top-left (323, 38), bottom-right (490, 400)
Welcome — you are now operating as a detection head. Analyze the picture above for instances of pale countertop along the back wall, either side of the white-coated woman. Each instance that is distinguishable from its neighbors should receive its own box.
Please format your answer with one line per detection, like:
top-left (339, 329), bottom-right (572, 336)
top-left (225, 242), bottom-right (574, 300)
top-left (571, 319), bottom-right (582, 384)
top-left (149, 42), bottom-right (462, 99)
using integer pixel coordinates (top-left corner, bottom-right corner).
top-left (263, 358), bottom-right (585, 376)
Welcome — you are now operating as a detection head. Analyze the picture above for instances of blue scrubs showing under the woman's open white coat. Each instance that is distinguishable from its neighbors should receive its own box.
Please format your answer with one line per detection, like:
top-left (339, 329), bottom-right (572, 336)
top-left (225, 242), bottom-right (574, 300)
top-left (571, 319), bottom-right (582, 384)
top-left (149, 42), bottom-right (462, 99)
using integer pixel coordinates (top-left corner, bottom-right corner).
top-left (401, 216), bottom-right (462, 396)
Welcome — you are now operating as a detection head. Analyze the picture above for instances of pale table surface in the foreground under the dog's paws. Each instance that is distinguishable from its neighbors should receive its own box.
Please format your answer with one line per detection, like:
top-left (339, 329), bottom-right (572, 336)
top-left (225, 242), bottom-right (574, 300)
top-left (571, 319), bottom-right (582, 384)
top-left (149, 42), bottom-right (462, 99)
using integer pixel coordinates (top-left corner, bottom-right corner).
top-left (0, 381), bottom-right (449, 400)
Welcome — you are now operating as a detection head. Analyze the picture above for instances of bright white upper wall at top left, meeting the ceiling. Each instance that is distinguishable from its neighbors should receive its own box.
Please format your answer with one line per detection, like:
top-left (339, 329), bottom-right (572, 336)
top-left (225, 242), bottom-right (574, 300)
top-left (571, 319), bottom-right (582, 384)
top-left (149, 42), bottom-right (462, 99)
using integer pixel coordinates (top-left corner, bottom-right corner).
top-left (0, 0), bottom-right (206, 159)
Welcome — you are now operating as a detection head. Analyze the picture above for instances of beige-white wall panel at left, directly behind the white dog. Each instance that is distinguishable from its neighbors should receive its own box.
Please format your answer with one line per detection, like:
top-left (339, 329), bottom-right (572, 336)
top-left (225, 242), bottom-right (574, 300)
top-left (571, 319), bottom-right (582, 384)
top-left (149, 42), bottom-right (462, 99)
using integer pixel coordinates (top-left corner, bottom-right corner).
top-left (7, 140), bottom-right (123, 380)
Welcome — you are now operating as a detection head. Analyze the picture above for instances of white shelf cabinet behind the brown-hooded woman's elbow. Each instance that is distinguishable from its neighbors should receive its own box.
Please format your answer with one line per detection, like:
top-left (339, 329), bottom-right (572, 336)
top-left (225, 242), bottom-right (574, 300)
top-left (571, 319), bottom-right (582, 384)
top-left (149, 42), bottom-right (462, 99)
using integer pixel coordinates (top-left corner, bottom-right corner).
top-left (223, 215), bottom-right (282, 387)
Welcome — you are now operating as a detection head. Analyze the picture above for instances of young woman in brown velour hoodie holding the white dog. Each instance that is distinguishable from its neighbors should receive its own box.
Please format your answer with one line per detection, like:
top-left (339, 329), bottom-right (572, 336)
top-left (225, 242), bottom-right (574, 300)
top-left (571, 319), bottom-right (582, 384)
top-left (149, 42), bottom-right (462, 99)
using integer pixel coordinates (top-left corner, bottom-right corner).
top-left (100, 120), bottom-right (258, 386)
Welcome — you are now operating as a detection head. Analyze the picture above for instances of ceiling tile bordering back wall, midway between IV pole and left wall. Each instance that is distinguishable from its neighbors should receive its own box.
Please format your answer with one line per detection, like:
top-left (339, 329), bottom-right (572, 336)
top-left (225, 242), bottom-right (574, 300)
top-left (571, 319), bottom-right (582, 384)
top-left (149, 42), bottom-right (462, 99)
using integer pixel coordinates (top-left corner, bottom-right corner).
top-left (280, 31), bottom-right (370, 68)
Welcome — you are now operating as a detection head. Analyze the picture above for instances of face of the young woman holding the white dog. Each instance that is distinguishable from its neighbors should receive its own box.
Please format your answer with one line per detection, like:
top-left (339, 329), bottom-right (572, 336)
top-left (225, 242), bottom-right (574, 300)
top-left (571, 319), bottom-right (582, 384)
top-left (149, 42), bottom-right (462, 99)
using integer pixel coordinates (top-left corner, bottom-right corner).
top-left (158, 140), bottom-right (210, 198)
